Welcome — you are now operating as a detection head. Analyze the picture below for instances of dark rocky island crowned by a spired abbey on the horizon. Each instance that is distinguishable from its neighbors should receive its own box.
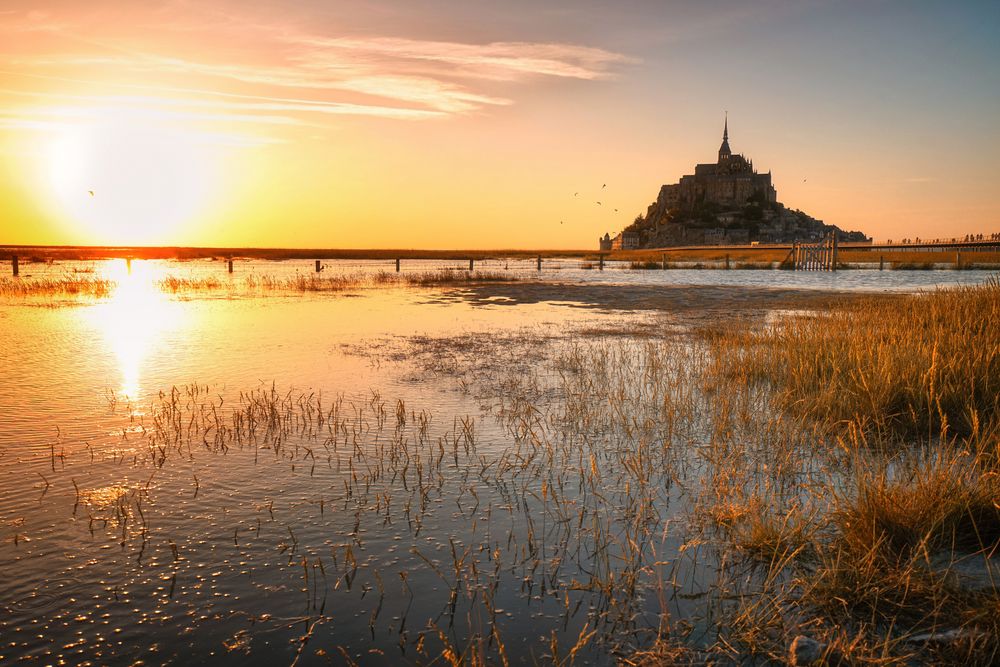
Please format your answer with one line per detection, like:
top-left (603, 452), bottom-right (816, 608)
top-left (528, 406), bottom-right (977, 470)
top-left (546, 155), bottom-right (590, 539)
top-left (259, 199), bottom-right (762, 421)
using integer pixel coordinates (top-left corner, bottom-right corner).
top-left (600, 117), bottom-right (868, 249)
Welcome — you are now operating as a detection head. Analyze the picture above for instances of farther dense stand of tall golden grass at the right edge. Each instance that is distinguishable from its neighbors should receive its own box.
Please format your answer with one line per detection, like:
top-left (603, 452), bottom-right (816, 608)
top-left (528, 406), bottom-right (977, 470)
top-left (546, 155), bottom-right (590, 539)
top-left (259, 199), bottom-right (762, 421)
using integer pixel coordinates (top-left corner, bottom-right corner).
top-left (714, 281), bottom-right (1000, 438)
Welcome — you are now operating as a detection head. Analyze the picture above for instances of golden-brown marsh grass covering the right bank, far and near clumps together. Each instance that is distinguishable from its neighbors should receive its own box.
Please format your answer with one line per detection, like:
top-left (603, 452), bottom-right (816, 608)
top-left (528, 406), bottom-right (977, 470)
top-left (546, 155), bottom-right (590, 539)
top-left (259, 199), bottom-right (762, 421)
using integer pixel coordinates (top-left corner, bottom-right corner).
top-left (698, 281), bottom-right (1000, 664)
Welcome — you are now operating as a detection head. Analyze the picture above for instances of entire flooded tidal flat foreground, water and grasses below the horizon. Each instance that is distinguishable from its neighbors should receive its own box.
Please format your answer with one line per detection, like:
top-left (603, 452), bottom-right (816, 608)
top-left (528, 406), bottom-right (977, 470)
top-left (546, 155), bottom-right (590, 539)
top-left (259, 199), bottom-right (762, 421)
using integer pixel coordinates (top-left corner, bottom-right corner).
top-left (0, 260), bottom-right (1000, 665)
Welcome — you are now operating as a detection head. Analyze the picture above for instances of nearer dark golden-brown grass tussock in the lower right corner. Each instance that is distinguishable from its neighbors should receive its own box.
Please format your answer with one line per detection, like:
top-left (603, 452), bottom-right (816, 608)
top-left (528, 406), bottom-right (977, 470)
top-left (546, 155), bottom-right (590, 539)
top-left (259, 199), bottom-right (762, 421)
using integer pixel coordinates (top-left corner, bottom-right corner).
top-left (798, 444), bottom-right (1000, 644)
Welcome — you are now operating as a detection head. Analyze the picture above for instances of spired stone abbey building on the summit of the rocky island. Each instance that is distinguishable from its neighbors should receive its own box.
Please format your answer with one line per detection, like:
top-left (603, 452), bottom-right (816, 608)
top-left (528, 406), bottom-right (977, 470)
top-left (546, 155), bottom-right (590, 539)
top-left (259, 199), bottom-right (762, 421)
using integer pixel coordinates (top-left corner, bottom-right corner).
top-left (657, 117), bottom-right (778, 211)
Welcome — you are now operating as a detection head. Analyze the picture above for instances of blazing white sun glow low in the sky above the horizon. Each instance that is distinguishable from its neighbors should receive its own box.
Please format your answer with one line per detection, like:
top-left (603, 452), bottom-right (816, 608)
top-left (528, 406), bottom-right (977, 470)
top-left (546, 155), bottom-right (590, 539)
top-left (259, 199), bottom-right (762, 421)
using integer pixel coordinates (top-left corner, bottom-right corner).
top-left (44, 110), bottom-right (214, 245)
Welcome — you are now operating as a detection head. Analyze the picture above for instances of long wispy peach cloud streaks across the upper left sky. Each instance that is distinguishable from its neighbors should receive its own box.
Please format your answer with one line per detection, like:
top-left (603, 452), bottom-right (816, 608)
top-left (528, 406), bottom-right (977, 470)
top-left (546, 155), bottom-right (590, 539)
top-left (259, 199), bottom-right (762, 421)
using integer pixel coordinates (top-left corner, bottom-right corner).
top-left (0, 5), bottom-right (637, 125)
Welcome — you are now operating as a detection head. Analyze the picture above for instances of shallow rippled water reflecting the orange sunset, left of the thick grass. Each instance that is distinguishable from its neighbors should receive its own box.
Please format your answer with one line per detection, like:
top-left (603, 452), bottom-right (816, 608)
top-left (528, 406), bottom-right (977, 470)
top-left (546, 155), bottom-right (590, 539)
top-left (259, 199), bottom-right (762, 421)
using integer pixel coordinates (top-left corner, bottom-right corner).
top-left (0, 261), bottom-right (985, 664)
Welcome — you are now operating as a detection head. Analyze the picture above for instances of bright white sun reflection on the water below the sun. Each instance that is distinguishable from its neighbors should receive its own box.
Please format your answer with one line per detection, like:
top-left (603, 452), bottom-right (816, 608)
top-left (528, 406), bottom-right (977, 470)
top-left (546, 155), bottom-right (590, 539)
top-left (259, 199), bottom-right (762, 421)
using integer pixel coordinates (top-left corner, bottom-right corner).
top-left (92, 261), bottom-right (184, 399)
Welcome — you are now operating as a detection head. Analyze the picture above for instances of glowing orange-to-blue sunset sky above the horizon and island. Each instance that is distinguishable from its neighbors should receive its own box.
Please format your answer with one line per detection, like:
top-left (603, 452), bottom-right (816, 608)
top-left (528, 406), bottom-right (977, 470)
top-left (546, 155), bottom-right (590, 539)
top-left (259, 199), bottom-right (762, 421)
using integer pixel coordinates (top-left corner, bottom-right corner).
top-left (0, 0), bottom-right (1000, 248)
